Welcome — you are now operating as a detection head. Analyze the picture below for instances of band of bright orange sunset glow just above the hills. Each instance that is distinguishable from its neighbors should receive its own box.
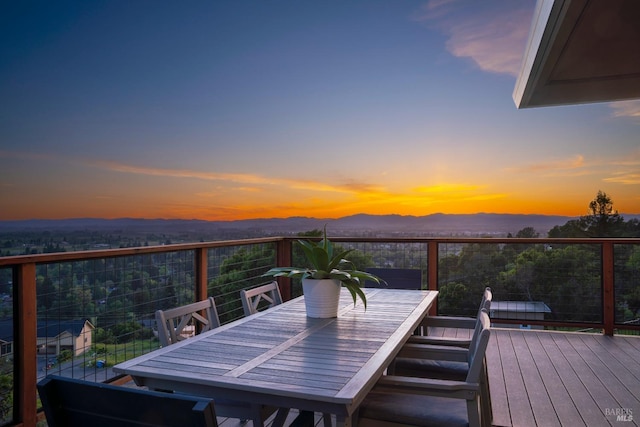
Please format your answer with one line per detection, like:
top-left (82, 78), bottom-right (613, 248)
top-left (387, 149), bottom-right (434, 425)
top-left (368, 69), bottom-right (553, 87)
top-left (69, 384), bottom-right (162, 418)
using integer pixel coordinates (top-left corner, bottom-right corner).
top-left (0, 180), bottom-right (640, 221)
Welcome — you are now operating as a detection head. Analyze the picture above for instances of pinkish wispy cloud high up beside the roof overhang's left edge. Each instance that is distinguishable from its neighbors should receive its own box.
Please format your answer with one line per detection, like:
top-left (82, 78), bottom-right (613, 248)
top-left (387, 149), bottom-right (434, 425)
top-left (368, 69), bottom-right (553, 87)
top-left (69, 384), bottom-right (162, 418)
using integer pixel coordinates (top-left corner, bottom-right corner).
top-left (416, 0), bottom-right (534, 76)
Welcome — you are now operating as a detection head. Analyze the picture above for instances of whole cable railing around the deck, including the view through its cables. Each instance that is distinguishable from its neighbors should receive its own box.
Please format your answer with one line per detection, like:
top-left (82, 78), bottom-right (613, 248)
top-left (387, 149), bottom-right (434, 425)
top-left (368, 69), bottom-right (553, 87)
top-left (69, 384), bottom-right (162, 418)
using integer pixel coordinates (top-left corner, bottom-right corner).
top-left (0, 237), bottom-right (640, 426)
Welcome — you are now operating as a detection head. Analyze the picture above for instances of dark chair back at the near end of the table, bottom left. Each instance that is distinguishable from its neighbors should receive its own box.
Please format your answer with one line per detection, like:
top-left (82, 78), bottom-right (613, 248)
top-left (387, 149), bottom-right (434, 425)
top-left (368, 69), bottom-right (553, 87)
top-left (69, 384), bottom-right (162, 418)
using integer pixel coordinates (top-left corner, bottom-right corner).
top-left (37, 375), bottom-right (218, 427)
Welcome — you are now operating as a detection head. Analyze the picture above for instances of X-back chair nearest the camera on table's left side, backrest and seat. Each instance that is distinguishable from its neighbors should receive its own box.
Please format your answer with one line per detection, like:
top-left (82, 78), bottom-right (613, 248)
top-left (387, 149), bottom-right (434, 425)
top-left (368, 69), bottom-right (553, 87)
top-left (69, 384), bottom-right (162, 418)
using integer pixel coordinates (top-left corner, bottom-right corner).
top-left (156, 297), bottom-right (289, 427)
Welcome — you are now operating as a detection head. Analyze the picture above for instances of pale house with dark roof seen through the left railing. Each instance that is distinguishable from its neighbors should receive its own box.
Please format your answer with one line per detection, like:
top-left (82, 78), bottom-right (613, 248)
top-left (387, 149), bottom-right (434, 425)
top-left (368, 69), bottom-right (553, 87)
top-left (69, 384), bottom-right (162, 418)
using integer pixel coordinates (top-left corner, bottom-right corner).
top-left (37, 320), bottom-right (95, 356)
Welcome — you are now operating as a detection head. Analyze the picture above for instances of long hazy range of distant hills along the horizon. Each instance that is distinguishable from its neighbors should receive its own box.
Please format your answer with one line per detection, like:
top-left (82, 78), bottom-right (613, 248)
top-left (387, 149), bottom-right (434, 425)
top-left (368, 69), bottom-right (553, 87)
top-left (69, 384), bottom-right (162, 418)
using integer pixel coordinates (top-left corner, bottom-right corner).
top-left (0, 213), bottom-right (584, 238)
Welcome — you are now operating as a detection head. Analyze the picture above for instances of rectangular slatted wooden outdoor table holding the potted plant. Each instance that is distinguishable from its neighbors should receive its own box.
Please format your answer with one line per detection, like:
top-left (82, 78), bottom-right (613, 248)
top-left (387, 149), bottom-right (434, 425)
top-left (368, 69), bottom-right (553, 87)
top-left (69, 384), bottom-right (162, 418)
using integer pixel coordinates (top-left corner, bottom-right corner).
top-left (113, 289), bottom-right (437, 426)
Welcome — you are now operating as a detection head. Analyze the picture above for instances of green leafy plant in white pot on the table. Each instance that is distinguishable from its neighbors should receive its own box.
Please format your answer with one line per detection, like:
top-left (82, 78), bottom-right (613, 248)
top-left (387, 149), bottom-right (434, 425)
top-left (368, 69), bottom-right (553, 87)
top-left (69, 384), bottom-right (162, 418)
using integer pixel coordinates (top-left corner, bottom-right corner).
top-left (264, 226), bottom-right (384, 317)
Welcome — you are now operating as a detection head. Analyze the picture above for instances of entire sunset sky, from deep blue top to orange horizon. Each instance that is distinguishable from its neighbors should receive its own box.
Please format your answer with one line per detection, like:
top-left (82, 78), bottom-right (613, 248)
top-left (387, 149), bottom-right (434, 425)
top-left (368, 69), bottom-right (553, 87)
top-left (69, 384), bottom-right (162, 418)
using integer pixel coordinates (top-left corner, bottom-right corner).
top-left (0, 0), bottom-right (640, 220)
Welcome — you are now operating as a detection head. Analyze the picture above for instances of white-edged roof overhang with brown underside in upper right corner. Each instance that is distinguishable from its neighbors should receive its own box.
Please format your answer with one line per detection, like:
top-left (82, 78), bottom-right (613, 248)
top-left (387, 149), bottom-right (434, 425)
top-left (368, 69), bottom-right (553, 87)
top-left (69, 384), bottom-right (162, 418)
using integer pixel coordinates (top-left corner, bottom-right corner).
top-left (513, 0), bottom-right (640, 108)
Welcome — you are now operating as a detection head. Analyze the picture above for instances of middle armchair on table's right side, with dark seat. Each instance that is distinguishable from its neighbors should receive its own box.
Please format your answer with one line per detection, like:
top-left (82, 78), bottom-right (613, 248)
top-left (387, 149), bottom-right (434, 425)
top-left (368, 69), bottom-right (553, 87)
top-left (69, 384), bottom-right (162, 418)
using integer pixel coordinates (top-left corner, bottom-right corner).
top-left (389, 308), bottom-right (492, 423)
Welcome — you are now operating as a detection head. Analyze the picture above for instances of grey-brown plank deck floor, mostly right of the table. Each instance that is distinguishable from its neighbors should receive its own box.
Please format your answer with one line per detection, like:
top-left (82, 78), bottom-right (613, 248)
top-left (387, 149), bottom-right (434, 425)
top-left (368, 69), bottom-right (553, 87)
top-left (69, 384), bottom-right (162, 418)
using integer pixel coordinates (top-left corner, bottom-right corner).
top-left (122, 328), bottom-right (640, 427)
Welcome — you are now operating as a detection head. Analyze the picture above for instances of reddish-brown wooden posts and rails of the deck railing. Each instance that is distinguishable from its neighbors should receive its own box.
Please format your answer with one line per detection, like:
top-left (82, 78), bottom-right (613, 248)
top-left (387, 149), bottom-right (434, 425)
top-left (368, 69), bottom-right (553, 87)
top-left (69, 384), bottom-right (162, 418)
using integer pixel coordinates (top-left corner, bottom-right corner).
top-left (0, 237), bottom-right (640, 427)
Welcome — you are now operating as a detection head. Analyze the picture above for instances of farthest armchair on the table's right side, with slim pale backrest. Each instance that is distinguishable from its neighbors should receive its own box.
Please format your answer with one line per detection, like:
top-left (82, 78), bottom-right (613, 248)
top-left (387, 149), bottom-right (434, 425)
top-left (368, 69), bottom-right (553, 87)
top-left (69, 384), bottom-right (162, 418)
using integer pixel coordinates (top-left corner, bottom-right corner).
top-left (408, 287), bottom-right (493, 347)
